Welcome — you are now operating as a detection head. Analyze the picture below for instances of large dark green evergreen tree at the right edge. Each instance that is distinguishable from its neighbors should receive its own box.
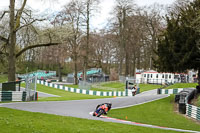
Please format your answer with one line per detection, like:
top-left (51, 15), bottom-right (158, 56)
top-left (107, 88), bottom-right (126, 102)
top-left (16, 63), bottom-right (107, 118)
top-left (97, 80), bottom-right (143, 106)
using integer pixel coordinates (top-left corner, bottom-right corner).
top-left (155, 0), bottom-right (200, 84)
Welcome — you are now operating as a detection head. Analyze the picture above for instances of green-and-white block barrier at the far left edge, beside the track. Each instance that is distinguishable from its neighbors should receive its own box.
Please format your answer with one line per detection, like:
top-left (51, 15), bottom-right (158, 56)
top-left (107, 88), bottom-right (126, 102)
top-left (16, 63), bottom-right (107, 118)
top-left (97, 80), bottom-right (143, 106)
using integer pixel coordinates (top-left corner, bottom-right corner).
top-left (0, 91), bottom-right (26, 102)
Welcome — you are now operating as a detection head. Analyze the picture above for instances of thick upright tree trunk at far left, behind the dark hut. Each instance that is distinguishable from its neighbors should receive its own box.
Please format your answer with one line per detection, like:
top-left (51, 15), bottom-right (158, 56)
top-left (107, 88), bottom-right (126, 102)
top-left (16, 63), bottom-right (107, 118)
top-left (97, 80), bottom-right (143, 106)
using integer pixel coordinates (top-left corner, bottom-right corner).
top-left (8, 0), bottom-right (16, 81)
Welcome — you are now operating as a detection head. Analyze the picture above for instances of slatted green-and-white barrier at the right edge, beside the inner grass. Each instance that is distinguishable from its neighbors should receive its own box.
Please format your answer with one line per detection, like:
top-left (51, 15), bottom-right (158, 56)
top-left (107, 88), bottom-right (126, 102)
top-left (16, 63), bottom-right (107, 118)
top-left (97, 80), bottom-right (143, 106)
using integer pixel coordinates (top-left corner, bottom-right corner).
top-left (186, 104), bottom-right (200, 121)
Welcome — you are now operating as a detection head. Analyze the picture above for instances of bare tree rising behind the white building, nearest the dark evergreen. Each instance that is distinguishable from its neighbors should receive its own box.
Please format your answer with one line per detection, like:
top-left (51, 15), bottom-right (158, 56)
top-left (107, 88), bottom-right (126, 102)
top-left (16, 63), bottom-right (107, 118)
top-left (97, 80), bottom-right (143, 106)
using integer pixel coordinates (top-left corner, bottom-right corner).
top-left (139, 4), bottom-right (164, 69)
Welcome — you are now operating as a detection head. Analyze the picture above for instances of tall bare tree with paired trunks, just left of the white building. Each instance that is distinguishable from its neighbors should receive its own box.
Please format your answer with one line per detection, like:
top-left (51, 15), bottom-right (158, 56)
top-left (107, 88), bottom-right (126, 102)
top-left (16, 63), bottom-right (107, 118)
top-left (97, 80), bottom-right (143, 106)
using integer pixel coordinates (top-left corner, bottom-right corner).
top-left (114, 0), bottom-right (134, 76)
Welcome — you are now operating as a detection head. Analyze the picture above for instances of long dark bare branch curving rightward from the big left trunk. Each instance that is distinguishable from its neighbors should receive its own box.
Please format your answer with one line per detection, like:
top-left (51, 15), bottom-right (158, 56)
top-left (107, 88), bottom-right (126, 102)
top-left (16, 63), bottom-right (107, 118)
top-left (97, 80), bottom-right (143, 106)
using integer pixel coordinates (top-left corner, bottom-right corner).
top-left (16, 43), bottom-right (61, 58)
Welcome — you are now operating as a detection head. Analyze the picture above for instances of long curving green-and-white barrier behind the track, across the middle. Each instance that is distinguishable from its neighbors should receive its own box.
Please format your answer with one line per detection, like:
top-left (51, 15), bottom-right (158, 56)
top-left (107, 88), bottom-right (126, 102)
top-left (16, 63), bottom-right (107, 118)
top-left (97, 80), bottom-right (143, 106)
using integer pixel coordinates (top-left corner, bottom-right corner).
top-left (37, 80), bottom-right (138, 97)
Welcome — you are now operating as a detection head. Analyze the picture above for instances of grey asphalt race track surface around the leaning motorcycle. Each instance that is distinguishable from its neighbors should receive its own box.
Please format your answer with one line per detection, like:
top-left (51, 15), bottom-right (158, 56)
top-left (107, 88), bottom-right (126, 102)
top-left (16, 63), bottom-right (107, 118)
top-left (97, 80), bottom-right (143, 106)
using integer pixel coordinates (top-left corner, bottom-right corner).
top-left (0, 90), bottom-right (200, 133)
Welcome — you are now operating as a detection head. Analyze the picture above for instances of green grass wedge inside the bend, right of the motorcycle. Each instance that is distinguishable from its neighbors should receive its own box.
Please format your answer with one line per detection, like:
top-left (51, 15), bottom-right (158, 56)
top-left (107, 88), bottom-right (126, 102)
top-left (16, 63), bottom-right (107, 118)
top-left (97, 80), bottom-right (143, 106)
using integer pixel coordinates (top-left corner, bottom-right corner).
top-left (108, 95), bottom-right (200, 131)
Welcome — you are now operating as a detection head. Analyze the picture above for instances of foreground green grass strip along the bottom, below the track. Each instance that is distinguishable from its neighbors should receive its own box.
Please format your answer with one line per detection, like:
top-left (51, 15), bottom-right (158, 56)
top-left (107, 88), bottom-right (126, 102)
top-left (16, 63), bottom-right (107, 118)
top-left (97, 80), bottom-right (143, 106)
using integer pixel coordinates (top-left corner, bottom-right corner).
top-left (0, 108), bottom-right (183, 133)
